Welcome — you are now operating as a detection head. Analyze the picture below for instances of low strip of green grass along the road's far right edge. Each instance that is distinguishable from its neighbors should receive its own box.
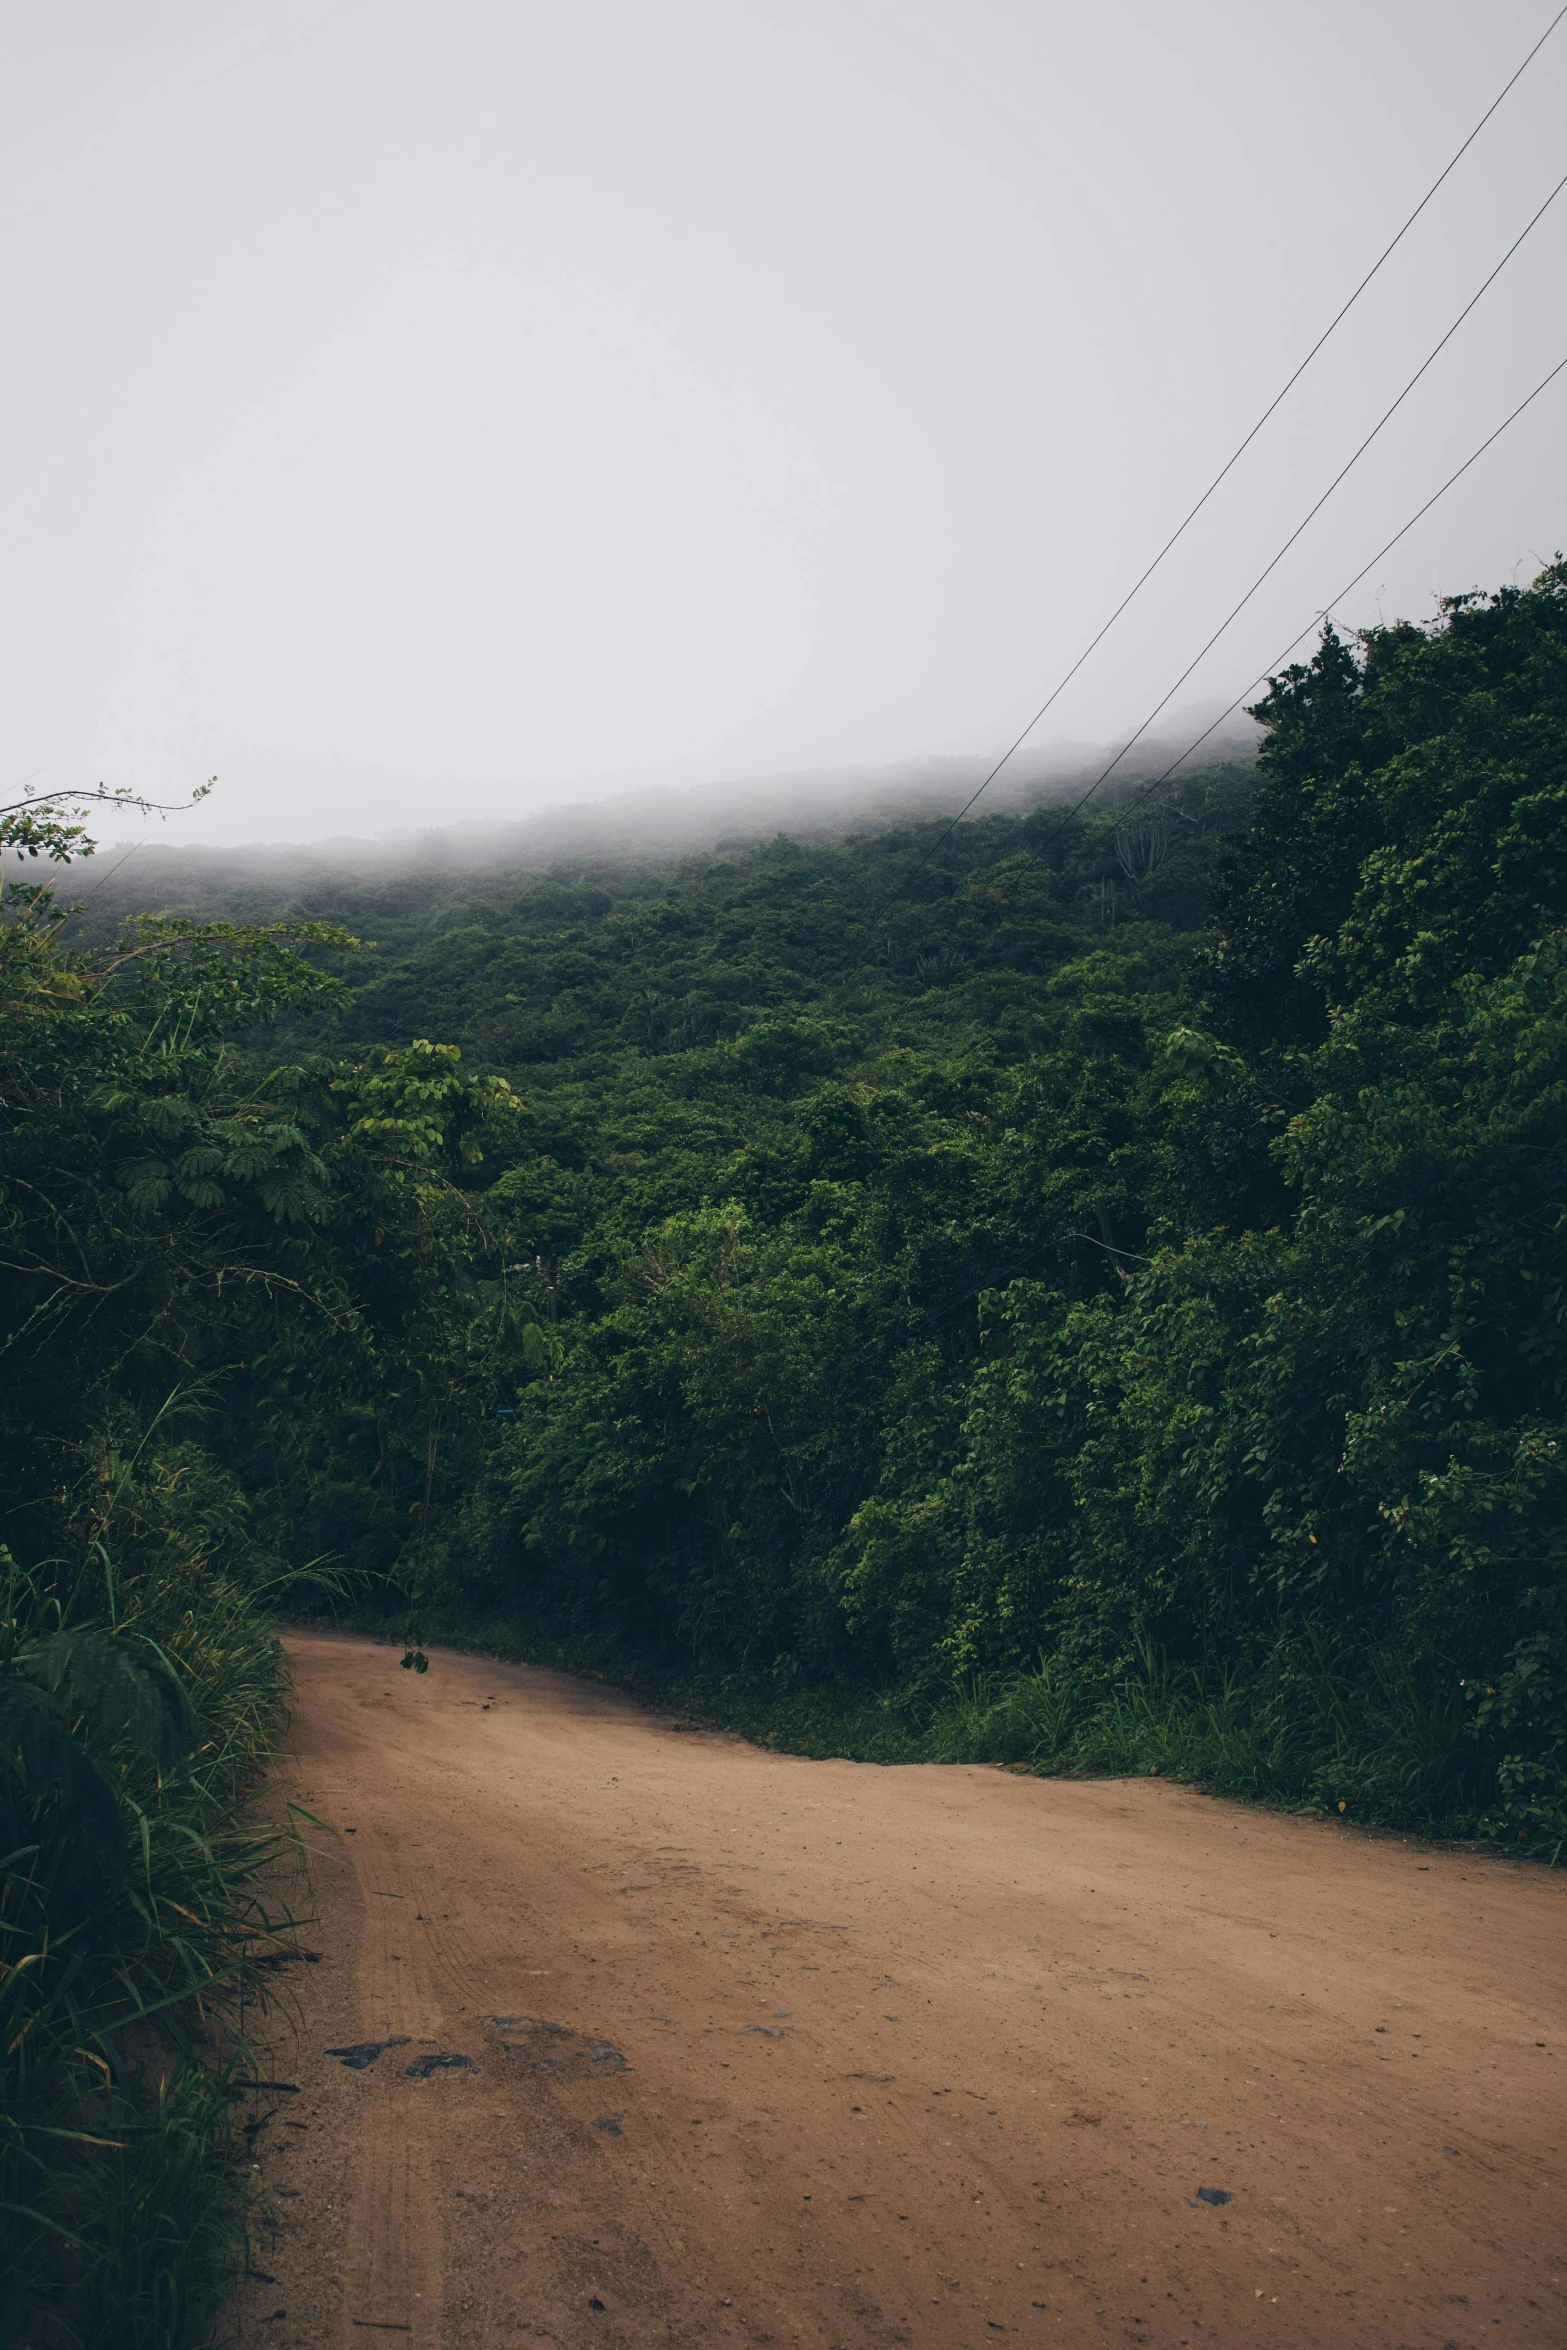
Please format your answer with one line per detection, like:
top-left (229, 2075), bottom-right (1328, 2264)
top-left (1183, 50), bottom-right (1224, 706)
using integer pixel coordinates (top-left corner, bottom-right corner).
top-left (338, 1605), bottom-right (1567, 1861)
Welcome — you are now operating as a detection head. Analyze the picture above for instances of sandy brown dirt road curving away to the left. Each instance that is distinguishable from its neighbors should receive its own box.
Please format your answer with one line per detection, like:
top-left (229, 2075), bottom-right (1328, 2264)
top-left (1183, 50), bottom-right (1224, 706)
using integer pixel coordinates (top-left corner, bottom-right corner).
top-left (237, 1636), bottom-right (1567, 2350)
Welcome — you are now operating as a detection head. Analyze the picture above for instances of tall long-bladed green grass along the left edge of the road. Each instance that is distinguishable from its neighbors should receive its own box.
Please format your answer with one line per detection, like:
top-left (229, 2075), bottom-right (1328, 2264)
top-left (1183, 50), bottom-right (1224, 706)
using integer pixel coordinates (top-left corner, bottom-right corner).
top-left (0, 1553), bottom-right (284, 2350)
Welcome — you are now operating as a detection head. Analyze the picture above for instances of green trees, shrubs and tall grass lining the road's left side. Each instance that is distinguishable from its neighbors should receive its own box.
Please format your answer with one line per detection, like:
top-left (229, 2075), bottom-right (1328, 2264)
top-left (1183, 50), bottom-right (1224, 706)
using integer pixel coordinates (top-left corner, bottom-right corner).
top-left (0, 813), bottom-right (510, 2350)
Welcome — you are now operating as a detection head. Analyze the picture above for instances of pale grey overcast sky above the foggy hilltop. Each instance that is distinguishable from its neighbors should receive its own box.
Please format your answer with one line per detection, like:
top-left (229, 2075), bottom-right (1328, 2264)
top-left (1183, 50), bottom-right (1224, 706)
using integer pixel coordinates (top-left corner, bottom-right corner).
top-left (0, 0), bottom-right (1567, 841)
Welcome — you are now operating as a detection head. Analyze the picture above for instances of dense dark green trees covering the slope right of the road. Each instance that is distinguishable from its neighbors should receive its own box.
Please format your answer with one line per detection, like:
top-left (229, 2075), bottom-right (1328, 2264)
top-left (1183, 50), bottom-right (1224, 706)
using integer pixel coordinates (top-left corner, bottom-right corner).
top-left (297, 559), bottom-right (1567, 1845)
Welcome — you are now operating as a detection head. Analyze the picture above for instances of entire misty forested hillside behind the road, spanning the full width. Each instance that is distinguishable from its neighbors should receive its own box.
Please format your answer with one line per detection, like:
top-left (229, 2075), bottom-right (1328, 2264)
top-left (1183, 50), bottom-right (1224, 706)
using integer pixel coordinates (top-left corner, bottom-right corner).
top-left (0, 566), bottom-right (1567, 2341)
